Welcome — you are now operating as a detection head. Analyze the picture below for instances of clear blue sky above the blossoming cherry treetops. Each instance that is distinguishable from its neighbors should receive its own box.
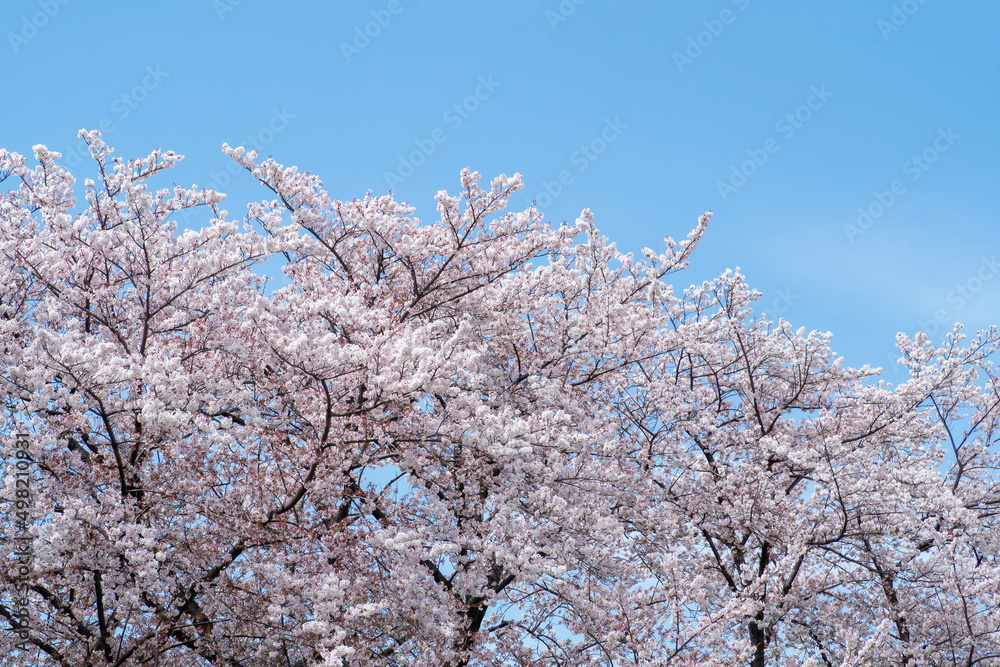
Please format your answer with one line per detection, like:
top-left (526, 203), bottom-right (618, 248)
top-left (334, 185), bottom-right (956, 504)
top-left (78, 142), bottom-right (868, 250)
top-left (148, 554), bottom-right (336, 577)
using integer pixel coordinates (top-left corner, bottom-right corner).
top-left (0, 0), bottom-right (1000, 379)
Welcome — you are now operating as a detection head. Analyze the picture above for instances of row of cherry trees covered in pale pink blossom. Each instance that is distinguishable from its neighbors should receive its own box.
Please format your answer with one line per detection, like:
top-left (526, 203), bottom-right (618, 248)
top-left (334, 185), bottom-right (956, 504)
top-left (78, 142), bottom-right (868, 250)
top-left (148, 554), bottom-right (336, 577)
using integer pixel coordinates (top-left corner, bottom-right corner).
top-left (0, 132), bottom-right (1000, 667)
